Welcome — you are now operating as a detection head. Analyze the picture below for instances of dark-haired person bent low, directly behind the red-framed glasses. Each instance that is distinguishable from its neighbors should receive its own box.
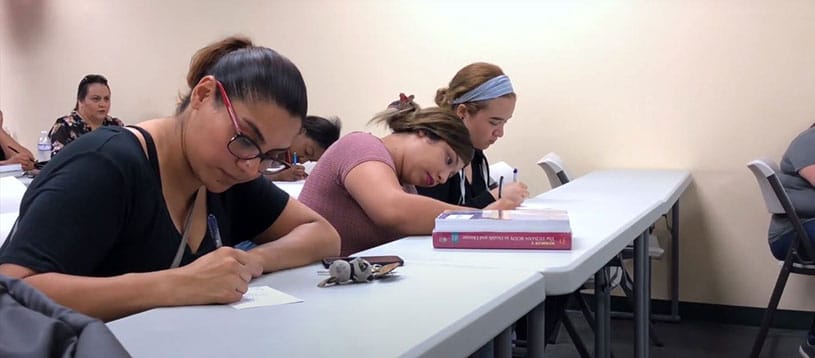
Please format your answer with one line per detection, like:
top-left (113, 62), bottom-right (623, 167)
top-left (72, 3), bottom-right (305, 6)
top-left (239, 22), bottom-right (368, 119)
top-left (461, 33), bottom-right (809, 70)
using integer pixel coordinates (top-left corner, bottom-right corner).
top-left (265, 116), bottom-right (342, 181)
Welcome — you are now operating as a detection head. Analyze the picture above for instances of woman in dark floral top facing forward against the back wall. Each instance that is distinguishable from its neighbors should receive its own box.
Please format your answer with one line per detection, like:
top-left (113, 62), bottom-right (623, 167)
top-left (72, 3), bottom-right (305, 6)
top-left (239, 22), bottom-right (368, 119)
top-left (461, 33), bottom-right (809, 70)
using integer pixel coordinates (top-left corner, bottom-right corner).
top-left (48, 75), bottom-right (124, 156)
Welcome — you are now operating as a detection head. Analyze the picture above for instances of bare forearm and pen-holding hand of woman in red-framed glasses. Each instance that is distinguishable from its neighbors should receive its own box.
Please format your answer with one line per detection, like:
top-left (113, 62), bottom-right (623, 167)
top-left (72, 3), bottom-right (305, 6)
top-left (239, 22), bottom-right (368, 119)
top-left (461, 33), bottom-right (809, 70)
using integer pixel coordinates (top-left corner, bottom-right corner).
top-left (0, 248), bottom-right (259, 321)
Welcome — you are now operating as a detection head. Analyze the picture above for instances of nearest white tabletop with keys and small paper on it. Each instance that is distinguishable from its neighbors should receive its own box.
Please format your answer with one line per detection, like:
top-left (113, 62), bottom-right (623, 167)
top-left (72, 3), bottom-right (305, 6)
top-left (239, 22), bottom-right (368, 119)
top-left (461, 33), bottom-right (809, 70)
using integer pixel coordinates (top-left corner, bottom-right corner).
top-left (108, 263), bottom-right (544, 357)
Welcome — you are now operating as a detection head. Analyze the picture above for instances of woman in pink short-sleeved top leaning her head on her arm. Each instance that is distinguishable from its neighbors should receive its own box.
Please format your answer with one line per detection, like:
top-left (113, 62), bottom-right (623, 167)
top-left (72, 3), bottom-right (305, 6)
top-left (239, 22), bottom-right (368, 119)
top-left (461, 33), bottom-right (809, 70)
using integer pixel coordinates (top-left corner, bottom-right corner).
top-left (299, 96), bottom-right (518, 255)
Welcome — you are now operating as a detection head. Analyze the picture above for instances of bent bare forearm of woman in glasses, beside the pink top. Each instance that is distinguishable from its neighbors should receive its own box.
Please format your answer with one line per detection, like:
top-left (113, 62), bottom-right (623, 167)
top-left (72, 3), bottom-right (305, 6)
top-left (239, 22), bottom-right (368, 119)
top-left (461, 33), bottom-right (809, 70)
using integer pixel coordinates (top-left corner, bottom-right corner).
top-left (248, 198), bottom-right (340, 272)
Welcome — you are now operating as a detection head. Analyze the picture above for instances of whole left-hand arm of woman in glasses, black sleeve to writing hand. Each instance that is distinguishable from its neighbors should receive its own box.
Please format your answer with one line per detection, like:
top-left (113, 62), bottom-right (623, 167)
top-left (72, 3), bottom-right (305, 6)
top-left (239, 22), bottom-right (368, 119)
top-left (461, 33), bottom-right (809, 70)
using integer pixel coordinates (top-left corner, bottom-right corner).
top-left (0, 152), bottom-right (260, 320)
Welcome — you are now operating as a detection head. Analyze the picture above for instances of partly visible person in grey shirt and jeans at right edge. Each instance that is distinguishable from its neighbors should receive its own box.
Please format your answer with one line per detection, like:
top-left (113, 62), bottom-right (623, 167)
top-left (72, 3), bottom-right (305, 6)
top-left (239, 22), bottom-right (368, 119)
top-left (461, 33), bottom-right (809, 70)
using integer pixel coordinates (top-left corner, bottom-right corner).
top-left (768, 125), bottom-right (815, 358)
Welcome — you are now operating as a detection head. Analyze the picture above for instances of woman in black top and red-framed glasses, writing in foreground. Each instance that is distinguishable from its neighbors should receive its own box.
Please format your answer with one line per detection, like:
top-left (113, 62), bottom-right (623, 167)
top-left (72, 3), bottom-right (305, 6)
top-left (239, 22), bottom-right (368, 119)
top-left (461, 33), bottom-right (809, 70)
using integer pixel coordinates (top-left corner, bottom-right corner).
top-left (0, 37), bottom-right (339, 320)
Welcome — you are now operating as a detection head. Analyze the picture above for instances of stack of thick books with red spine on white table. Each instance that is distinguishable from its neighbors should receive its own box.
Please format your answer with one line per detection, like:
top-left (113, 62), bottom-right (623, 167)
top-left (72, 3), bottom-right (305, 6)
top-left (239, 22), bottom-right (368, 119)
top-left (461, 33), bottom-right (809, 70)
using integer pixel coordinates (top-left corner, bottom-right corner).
top-left (433, 209), bottom-right (572, 250)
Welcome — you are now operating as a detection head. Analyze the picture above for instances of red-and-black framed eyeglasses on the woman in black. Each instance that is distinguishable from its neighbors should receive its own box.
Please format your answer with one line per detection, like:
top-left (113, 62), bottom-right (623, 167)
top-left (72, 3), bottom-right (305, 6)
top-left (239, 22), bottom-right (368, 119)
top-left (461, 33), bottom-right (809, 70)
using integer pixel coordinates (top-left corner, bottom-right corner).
top-left (215, 81), bottom-right (291, 174)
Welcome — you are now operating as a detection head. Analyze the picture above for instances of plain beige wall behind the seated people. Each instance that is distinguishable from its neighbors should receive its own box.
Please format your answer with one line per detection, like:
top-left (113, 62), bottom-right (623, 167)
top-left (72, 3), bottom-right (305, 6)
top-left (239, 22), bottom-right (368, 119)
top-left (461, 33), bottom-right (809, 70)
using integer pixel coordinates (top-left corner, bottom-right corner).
top-left (0, 0), bottom-right (815, 310)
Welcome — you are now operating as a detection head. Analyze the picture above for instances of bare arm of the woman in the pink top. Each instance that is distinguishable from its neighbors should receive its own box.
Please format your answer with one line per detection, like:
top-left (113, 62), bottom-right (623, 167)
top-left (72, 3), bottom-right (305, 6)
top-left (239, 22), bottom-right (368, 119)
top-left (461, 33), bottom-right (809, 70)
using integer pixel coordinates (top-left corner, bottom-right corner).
top-left (345, 161), bottom-right (471, 235)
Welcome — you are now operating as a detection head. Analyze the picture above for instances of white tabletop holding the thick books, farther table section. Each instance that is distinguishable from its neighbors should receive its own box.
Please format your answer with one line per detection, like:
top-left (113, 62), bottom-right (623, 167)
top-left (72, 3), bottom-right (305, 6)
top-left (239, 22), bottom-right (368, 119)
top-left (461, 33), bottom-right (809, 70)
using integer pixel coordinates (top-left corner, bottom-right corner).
top-left (355, 170), bottom-right (690, 295)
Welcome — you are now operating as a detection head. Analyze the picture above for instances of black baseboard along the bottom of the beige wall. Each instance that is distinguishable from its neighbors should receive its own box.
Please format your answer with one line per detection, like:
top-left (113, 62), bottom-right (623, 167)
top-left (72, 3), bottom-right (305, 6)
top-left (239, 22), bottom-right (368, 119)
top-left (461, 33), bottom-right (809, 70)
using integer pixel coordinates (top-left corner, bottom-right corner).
top-left (570, 295), bottom-right (815, 330)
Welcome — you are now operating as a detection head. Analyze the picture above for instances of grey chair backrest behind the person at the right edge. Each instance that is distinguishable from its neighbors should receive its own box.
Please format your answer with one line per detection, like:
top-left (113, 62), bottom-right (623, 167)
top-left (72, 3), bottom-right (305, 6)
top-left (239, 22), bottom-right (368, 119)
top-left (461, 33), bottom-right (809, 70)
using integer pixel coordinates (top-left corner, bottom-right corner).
top-left (747, 158), bottom-right (815, 263)
